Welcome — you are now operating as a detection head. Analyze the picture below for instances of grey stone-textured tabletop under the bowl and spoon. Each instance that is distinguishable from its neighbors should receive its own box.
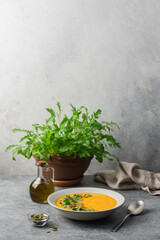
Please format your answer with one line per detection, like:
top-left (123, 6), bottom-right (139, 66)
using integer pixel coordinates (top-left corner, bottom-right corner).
top-left (0, 175), bottom-right (160, 240)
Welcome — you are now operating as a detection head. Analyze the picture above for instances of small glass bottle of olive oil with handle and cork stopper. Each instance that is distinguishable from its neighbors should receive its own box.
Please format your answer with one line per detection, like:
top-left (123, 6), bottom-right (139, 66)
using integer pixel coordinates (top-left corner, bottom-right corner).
top-left (29, 161), bottom-right (55, 203)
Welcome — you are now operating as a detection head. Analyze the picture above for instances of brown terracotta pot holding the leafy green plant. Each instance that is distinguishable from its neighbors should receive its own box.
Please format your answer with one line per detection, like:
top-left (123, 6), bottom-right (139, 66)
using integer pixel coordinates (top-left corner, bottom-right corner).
top-left (35, 155), bottom-right (93, 186)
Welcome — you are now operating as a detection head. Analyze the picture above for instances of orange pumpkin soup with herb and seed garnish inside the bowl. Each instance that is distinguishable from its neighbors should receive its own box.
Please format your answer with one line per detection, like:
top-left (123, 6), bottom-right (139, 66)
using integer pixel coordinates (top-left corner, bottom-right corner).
top-left (56, 193), bottom-right (117, 212)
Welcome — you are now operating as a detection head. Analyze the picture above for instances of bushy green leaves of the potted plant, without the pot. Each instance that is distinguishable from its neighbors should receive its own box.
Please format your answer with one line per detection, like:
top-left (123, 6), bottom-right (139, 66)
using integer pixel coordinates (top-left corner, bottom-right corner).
top-left (5, 102), bottom-right (120, 162)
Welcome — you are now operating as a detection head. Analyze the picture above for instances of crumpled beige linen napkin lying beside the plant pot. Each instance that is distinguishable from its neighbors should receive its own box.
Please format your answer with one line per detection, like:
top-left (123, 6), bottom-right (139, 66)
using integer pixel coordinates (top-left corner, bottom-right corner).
top-left (94, 162), bottom-right (160, 195)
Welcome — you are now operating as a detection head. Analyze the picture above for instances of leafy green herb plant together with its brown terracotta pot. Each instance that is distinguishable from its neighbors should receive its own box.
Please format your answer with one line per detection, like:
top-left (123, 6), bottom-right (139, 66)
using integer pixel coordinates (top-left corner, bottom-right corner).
top-left (5, 102), bottom-right (120, 186)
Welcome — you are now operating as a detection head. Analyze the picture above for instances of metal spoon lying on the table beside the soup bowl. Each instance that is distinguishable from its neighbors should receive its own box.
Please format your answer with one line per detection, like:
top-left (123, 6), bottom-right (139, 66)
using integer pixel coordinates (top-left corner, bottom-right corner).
top-left (111, 200), bottom-right (144, 232)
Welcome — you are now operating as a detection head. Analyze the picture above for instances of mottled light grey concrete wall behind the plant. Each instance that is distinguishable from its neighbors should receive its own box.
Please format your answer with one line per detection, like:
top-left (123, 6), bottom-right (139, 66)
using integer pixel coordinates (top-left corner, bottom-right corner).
top-left (0, 0), bottom-right (160, 174)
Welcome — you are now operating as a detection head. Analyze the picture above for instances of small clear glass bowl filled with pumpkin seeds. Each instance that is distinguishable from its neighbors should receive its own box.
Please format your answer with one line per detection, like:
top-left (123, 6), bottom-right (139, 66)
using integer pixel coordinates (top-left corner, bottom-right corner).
top-left (28, 213), bottom-right (50, 227)
